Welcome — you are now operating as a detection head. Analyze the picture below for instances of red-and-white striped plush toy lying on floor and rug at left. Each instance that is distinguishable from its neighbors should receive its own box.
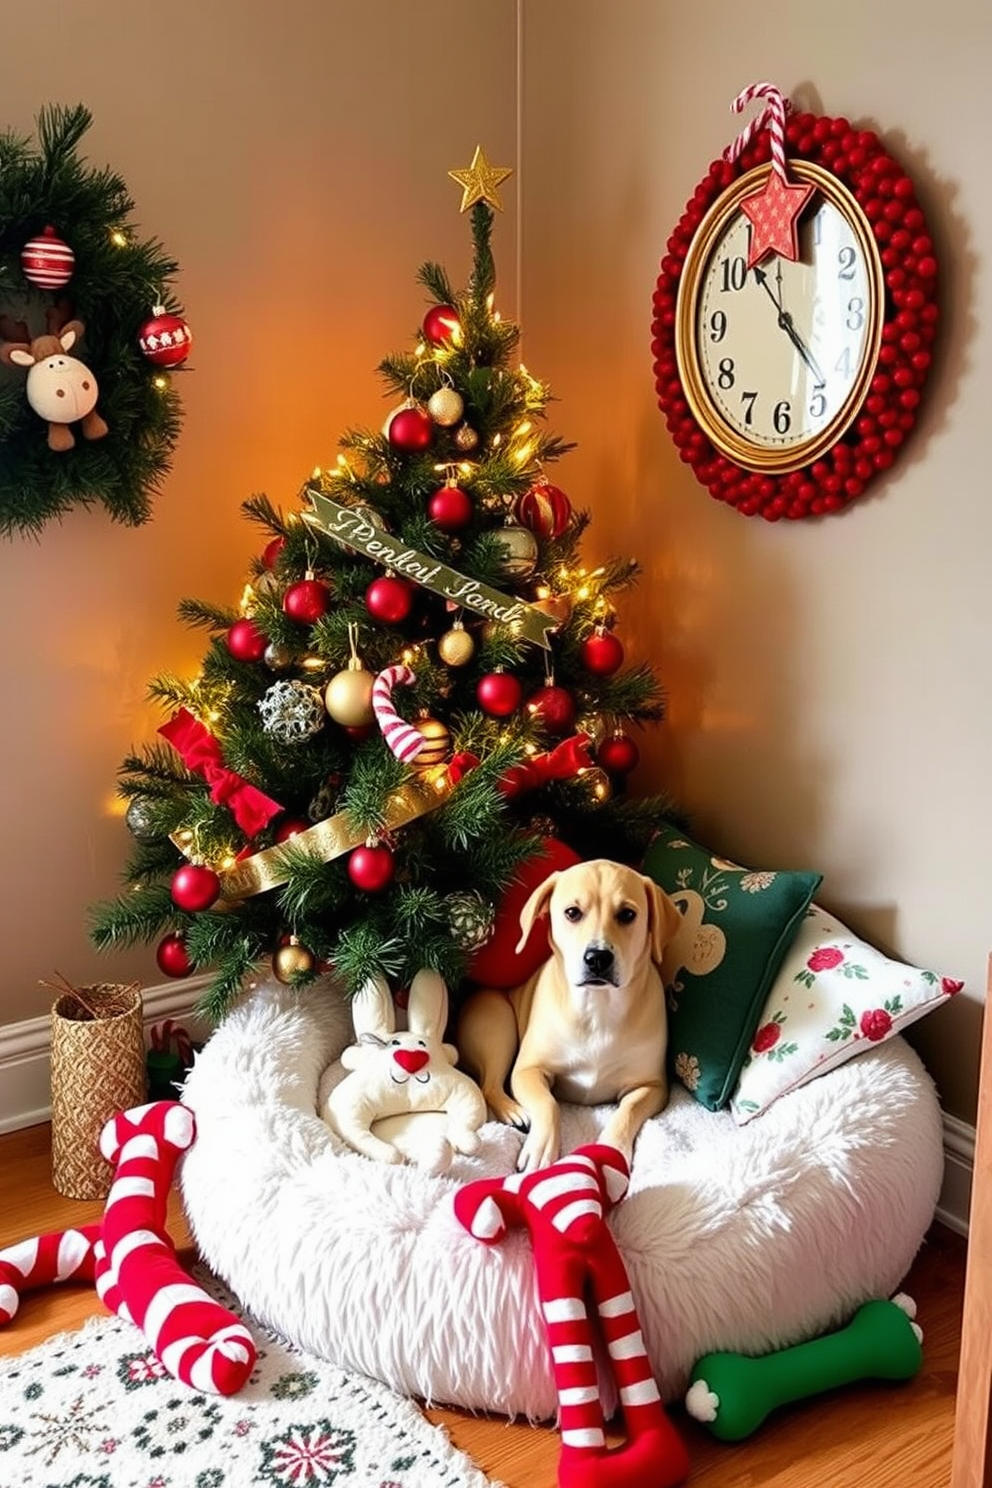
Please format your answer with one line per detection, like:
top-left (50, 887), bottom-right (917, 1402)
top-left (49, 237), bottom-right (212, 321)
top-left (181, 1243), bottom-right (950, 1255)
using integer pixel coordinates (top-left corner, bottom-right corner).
top-left (0, 1101), bottom-right (256, 1394)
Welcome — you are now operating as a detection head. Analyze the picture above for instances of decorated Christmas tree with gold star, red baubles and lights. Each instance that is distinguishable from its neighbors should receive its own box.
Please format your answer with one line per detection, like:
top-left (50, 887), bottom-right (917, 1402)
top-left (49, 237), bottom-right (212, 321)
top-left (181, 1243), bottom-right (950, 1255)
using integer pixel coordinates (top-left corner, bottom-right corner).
top-left (94, 149), bottom-right (668, 1016)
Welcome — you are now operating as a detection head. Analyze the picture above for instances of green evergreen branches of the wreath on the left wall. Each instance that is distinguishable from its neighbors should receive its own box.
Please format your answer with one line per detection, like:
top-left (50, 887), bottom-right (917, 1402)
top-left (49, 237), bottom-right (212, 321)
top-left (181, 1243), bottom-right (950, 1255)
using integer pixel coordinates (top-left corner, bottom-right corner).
top-left (0, 104), bottom-right (180, 537)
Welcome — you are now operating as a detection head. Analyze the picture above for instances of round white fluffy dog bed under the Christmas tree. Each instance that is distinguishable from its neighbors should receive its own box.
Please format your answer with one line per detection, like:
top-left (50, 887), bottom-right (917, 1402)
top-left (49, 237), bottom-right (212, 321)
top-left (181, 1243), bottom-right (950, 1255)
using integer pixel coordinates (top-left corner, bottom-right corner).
top-left (181, 984), bottom-right (943, 1420)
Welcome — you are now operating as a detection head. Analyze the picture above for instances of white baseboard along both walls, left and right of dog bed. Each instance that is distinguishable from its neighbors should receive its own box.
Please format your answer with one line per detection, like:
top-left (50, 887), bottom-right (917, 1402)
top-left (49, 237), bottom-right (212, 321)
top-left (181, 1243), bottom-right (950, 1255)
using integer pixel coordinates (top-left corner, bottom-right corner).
top-left (0, 1005), bottom-right (974, 1235)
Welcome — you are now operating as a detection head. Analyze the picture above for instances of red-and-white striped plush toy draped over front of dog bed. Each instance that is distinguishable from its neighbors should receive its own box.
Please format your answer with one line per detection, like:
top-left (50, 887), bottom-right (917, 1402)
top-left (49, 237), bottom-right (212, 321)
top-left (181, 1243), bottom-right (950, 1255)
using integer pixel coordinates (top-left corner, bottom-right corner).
top-left (455, 1143), bottom-right (689, 1488)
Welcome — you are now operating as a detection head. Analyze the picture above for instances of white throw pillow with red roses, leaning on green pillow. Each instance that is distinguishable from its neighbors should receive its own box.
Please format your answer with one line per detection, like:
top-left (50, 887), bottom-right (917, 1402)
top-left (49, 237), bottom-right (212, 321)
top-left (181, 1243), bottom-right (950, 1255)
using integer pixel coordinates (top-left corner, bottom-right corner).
top-left (730, 905), bottom-right (964, 1125)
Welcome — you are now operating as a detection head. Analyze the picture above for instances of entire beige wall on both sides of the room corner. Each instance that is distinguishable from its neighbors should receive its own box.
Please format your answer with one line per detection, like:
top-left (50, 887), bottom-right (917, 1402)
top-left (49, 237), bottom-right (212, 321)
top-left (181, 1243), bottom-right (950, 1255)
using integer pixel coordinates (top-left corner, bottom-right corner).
top-left (0, 0), bottom-right (992, 1117)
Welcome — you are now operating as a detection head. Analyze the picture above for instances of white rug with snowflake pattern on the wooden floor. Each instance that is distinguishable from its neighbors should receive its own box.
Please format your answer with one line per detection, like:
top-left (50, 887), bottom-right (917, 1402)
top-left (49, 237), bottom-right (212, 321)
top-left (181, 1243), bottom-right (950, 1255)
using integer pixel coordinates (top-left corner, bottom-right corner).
top-left (0, 1298), bottom-right (494, 1488)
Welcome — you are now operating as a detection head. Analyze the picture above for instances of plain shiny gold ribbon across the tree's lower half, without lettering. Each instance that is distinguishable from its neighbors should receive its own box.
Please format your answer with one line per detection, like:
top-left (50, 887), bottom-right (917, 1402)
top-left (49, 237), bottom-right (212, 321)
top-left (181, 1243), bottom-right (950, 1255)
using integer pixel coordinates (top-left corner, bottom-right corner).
top-left (173, 765), bottom-right (455, 908)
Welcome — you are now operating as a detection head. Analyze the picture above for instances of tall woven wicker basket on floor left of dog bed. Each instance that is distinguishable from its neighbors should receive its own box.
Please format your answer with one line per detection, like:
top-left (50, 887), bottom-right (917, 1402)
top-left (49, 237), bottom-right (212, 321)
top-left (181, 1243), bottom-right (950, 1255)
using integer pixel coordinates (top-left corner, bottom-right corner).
top-left (52, 982), bottom-right (147, 1199)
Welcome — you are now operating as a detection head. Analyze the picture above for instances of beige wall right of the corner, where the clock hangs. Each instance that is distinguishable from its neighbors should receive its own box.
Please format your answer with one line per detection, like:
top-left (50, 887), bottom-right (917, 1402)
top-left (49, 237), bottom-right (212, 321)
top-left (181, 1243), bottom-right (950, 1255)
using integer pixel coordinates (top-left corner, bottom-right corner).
top-left (522, 0), bottom-right (992, 1117)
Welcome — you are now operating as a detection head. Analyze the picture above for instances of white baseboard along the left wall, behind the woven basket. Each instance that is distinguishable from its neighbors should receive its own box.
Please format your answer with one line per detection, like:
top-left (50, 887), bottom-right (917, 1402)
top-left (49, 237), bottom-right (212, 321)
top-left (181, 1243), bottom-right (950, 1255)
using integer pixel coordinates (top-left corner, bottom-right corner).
top-left (0, 976), bottom-right (210, 1132)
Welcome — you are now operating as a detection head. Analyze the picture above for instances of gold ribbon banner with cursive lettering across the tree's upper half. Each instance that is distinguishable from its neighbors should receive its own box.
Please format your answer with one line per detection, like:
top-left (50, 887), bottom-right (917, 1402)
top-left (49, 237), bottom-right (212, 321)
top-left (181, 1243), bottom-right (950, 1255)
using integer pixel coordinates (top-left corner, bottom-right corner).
top-left (302, 485), bottom-right (561, 650)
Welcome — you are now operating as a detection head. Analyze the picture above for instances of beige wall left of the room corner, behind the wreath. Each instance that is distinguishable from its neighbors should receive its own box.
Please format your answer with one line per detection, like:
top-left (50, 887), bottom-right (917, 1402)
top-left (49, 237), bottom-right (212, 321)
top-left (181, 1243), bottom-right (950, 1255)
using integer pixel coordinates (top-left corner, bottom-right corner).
top-left (0, 0), bottom-right (516, 1024)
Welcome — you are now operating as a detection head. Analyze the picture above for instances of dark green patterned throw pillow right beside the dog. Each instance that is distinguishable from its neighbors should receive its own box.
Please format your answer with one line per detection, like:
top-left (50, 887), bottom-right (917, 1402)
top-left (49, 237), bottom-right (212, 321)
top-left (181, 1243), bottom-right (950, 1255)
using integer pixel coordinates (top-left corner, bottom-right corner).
top-left (644, 826), bottom-right (822, 1110)
